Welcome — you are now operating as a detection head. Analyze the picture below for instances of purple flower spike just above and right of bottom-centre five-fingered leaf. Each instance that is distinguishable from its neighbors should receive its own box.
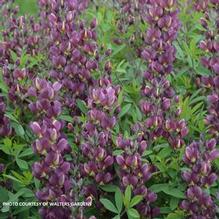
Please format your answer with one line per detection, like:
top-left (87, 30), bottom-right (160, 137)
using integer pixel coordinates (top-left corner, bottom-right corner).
top-left (116, 136), bottom-right (159, 218)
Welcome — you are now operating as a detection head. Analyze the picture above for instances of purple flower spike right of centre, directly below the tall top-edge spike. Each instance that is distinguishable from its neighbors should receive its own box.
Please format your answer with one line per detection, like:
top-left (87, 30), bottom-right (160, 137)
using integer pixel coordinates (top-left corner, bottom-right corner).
top-left (140, 72), bottom-right (188, 148)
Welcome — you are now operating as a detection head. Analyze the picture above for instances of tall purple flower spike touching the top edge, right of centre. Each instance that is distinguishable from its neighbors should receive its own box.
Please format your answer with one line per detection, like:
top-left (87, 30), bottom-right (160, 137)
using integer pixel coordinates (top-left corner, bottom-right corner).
top-left (142, 0), bottom-right (180, 75)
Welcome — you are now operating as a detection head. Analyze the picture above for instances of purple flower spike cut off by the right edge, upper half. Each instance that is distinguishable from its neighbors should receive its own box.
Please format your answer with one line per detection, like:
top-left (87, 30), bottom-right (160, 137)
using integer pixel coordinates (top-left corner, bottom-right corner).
top-left (200, 0), bottom-right (219, 137)
